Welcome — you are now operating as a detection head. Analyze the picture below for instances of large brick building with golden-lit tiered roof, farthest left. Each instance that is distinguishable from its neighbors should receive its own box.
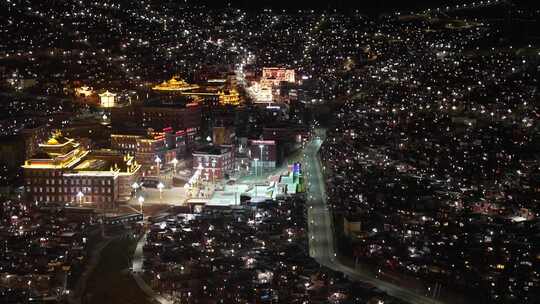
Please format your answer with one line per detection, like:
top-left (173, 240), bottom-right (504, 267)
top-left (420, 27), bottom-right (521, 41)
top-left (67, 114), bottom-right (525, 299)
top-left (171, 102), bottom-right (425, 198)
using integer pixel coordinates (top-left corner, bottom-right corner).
top-left (22, 132), bottom-right (141, 208)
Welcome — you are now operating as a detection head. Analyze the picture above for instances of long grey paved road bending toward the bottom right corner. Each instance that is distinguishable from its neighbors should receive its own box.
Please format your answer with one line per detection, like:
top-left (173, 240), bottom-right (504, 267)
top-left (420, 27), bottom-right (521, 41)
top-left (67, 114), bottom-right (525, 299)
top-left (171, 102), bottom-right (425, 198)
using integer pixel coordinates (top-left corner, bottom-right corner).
top-left (304, 130), bottom-right (441, 304)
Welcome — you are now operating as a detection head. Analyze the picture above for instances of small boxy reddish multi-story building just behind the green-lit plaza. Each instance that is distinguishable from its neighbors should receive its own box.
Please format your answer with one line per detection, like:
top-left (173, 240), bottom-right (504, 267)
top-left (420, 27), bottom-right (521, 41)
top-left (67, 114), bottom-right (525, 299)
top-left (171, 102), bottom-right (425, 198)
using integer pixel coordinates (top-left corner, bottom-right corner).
top-left (193, 146), bottom-right (234, 181)
